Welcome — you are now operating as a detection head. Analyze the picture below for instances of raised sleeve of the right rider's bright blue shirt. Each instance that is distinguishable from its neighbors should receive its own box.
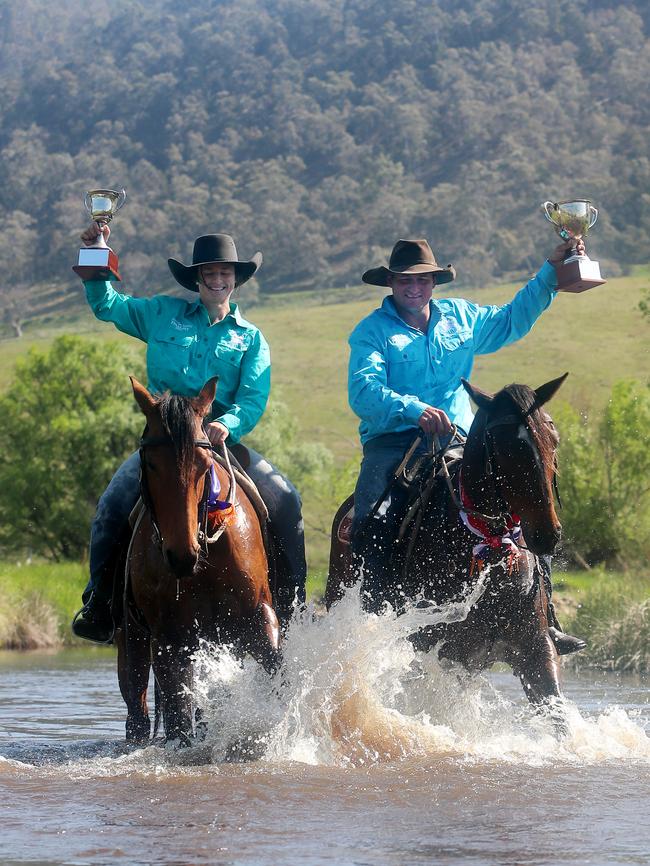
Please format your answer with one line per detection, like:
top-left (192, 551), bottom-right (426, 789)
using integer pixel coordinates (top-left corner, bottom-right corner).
top-left (472, 262), bottom-right (557, 355)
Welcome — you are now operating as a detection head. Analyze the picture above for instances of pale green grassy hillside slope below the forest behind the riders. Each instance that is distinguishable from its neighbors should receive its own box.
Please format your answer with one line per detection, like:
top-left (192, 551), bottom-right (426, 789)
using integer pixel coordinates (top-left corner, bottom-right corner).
top-left (0, 267), bottom-right (650, 457)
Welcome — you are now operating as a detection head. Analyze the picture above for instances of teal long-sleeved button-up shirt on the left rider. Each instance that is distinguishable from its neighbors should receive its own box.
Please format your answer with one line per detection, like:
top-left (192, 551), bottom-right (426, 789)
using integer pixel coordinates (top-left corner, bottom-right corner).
top-left (84, 281), bottom-right (271, 443)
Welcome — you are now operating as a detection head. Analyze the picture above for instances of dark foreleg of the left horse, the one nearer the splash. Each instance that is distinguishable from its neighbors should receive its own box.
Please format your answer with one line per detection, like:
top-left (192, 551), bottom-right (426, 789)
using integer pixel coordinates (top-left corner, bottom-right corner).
top-left (152, 635), bottom-right (194, 745)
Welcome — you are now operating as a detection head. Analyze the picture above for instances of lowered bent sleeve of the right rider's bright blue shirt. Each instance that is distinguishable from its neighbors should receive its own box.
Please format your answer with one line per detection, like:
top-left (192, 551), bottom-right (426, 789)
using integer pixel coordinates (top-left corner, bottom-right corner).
top-left (348, 332), bottom-right (426, 433)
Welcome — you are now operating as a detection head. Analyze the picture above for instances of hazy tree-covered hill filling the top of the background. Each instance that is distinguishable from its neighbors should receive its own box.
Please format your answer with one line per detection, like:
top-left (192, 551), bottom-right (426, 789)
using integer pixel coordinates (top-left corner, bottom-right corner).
top-left (0, 0), bottom-right (650, 314)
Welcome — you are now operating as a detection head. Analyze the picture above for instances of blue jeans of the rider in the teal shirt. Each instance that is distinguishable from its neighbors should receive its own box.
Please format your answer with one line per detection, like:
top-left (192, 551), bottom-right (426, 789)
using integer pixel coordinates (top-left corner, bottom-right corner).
top-left (82, 448), bottom-right (307, 610)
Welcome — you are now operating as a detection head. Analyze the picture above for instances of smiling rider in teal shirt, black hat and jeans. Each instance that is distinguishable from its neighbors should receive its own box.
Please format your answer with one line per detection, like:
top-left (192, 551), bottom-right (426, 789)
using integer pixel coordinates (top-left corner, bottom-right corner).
top-left (72, 222), bottom-right (306, 643)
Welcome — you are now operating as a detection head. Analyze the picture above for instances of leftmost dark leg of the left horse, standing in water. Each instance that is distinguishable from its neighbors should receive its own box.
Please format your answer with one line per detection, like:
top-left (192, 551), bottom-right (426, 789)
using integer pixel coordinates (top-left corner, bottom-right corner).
top-left (115, 623), bottom-right (151, 743)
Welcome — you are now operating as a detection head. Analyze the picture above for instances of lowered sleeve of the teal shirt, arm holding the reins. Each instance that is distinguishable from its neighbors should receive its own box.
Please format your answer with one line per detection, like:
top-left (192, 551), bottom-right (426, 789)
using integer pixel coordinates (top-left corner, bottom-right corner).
top-left (211, 331), bottom-right (271, 442)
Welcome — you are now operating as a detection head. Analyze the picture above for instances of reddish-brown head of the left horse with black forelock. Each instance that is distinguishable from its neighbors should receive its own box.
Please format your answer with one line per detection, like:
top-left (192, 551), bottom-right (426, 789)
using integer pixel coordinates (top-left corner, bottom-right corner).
top-left (131, 377), bottom-right (217, 578)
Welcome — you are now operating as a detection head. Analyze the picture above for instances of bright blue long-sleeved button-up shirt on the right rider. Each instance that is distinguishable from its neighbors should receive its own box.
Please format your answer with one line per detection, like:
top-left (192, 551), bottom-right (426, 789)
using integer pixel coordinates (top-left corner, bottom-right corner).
top-left (348, 262), bottom-right (557, 443)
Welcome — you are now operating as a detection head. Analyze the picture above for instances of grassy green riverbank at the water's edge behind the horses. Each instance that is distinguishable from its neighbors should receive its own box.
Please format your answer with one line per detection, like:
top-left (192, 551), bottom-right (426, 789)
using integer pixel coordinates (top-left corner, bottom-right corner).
top-left (0, 563), bottom-right (650, 673)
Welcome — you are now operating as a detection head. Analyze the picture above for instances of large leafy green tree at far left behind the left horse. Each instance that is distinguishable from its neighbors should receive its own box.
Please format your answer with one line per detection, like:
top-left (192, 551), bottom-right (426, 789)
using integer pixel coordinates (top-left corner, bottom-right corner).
top-left (0, 336), bottom-right (143, 560)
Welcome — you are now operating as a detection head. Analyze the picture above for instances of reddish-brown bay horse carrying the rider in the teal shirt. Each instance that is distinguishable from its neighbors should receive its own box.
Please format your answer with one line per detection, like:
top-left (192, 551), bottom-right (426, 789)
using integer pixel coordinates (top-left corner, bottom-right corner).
top-left (115, 378), bottom-right (279, 744)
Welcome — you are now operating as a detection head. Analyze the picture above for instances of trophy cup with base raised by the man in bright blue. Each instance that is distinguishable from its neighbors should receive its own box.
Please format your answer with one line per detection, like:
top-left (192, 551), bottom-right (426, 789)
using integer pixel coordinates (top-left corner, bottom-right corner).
top-left (542, 199), bottom-right (606, 292)
